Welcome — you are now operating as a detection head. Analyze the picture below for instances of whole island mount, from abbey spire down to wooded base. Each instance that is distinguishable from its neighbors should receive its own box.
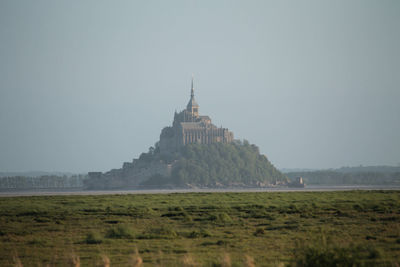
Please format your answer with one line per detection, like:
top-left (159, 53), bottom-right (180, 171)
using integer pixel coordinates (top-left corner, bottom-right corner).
top-left (84, 77), bottom-right (287, 189)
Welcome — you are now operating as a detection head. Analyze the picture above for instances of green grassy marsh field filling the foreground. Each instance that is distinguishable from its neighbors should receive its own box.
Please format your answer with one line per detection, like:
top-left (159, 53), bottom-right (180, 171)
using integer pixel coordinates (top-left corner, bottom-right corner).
top-left (0, 191), bottom-right (400, 266)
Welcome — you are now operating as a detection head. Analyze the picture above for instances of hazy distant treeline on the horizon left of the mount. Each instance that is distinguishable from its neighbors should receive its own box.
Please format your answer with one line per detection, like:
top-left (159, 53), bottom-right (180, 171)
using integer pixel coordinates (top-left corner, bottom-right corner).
top-left (0, 175), bottom-right (86, 190)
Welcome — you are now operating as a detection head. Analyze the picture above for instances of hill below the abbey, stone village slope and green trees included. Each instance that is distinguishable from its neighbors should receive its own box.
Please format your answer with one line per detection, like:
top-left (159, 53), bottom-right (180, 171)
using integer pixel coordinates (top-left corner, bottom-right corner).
top-left (85, 141), bottom-right (288, 189)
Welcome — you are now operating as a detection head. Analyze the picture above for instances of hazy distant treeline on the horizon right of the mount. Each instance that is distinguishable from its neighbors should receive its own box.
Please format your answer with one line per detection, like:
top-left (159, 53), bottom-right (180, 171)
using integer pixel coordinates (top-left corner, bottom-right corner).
top-left (286, 169), bottom-right (400, 185)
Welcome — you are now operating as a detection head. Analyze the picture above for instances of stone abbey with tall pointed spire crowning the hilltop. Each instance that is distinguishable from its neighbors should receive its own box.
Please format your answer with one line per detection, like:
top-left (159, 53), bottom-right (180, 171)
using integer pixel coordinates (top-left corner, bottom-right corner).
top-left (159, 77), bottom-right (233, 153)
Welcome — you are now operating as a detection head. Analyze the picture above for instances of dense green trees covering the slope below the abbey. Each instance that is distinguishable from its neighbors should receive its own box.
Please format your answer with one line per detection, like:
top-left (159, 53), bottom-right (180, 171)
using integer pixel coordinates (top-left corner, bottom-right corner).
top-left (140, 141), bottom-right (287, 187)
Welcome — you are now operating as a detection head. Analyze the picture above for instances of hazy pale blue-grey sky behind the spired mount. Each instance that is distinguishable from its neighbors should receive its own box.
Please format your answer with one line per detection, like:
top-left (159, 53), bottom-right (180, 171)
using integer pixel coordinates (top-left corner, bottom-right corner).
top-left (0, 0), bottom-right (400, 172)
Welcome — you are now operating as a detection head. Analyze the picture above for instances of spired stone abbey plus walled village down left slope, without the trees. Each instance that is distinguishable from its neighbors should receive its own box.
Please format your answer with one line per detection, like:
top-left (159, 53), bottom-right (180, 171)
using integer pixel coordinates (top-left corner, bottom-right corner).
top-left (85, 77), bottom-right (248, 189)
